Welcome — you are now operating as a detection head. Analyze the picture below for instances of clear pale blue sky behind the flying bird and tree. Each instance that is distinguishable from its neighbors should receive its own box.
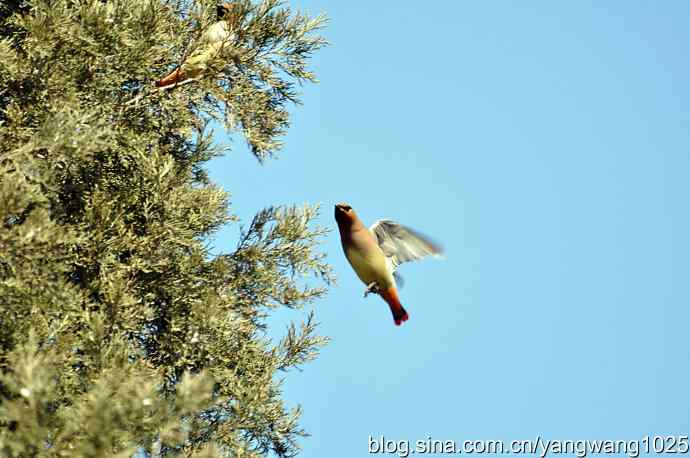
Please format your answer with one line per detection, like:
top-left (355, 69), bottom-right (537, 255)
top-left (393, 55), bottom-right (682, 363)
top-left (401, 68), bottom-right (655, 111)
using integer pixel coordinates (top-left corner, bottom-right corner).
top-left (209, 0), bottom-right (690, 458)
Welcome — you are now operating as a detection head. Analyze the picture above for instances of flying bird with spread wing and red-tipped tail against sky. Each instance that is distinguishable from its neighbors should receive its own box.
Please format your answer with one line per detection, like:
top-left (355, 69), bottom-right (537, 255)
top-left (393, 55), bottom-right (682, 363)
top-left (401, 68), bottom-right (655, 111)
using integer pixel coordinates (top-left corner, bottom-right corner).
top-left (335, 203), bottom-right (443, 326)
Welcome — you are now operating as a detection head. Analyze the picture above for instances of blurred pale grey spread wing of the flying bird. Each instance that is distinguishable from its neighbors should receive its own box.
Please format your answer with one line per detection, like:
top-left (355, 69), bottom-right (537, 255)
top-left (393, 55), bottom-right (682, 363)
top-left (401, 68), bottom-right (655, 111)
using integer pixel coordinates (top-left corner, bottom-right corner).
top-left (369, 219), bottom-right (443, 270)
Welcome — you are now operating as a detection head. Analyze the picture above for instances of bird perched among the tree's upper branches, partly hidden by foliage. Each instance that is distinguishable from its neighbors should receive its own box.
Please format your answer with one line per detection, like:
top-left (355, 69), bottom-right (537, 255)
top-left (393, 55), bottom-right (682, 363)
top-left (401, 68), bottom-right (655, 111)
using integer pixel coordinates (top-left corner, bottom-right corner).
top-left (156, 3), bottom-right (240, 87)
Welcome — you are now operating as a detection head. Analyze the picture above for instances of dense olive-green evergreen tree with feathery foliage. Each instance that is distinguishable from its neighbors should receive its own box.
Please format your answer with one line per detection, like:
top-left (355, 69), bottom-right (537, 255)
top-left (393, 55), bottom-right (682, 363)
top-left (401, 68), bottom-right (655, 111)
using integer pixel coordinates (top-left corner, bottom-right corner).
top-left (0, 0), bottom-right (332, 457)
